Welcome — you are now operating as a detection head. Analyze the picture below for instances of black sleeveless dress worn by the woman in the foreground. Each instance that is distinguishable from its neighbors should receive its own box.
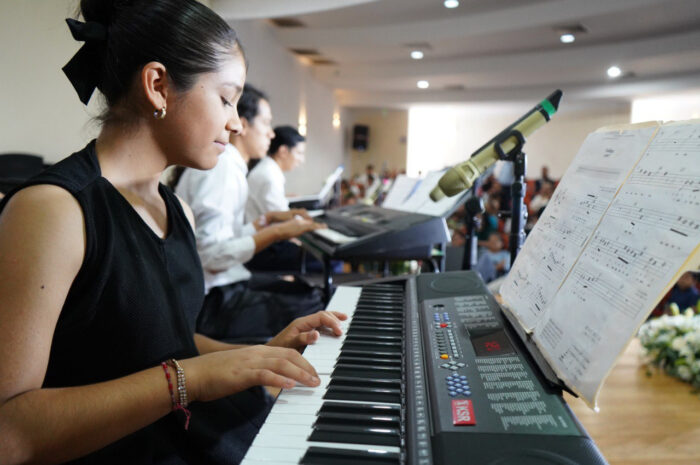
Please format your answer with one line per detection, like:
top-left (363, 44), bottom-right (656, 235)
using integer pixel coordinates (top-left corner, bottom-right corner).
top-left (0, 141), bottom-right (264, 465)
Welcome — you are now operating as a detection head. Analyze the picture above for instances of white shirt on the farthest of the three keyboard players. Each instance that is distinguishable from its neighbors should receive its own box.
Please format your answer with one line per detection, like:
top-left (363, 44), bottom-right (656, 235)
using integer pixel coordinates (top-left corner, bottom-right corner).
top-left (245, 157), bottom-right (289, 221)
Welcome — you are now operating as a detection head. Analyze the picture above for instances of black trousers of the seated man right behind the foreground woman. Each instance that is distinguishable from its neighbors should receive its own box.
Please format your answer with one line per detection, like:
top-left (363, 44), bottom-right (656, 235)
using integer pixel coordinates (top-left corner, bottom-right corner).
top-left (197, 274), bottom-right (323, 341)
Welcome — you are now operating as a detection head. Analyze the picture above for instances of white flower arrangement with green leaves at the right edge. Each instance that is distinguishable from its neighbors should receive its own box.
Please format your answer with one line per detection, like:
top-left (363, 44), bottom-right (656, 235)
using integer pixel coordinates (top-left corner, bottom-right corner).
top-left (639, 304), bottom-right (700, 392)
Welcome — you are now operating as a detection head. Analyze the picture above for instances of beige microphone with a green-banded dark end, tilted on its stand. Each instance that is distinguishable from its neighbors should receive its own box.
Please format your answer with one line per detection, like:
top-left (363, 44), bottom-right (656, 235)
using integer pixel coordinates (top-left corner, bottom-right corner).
top-left (430, 89), bottom-right (562, 202)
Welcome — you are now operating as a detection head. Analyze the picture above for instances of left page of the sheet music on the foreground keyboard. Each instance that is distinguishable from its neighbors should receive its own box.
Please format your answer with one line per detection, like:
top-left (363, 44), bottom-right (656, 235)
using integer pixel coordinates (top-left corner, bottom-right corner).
top-left (500, 124), bottom-right (658, 332)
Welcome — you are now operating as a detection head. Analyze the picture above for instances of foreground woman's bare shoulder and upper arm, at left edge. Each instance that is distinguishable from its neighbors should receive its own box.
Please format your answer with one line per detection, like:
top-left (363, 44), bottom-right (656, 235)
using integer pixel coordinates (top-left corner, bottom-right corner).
top-left (0, 185), bottom-right (85, 402)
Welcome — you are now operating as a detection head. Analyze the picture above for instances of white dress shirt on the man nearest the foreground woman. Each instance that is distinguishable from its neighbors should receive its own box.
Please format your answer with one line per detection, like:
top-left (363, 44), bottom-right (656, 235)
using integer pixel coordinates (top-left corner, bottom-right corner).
top-left (175, 144), bottom-right (255, 292)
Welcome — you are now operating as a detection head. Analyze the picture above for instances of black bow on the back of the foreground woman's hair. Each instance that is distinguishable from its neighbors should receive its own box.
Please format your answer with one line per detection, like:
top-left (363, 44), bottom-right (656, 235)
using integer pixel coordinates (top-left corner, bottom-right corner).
top-left (62, 18), bottom-right (107, 105)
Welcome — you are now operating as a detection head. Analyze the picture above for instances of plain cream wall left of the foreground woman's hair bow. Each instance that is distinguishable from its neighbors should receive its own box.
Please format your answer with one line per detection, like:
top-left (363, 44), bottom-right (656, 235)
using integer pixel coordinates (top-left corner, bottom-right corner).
top-left (0, 0), bottom-right (99, 162)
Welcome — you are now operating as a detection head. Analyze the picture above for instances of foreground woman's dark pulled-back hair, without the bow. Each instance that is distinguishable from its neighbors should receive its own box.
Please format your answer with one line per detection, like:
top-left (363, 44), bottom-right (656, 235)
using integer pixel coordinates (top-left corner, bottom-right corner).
top-left (80, 0), bottom-right (242, 119)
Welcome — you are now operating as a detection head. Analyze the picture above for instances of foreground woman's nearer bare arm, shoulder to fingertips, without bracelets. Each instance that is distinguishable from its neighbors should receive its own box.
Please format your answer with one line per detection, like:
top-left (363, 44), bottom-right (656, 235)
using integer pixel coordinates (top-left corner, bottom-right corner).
top-left (0, 186), bottom-right (318, 464)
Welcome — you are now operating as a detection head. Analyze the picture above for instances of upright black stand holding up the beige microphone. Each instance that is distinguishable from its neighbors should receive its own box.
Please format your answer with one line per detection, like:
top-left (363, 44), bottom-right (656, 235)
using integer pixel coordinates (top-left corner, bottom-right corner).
top-left (494, 129), bottom-right (527, 266)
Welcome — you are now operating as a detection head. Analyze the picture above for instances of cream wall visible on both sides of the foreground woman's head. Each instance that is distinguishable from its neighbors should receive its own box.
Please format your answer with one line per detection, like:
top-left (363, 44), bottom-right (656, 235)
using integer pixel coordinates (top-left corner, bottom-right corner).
top-left (0, 0), bottom-right (343, 194)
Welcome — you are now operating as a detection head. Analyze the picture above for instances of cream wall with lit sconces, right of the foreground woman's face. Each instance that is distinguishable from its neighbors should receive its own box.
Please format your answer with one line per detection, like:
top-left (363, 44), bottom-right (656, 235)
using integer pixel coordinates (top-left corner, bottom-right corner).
top-left (230, 20), bottom-right (343, 194)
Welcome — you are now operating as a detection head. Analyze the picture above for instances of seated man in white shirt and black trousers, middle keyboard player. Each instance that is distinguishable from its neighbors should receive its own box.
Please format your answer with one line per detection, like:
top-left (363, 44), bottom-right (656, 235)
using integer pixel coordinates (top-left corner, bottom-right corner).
top-left (174, 84), bottom-right (323, 340)
